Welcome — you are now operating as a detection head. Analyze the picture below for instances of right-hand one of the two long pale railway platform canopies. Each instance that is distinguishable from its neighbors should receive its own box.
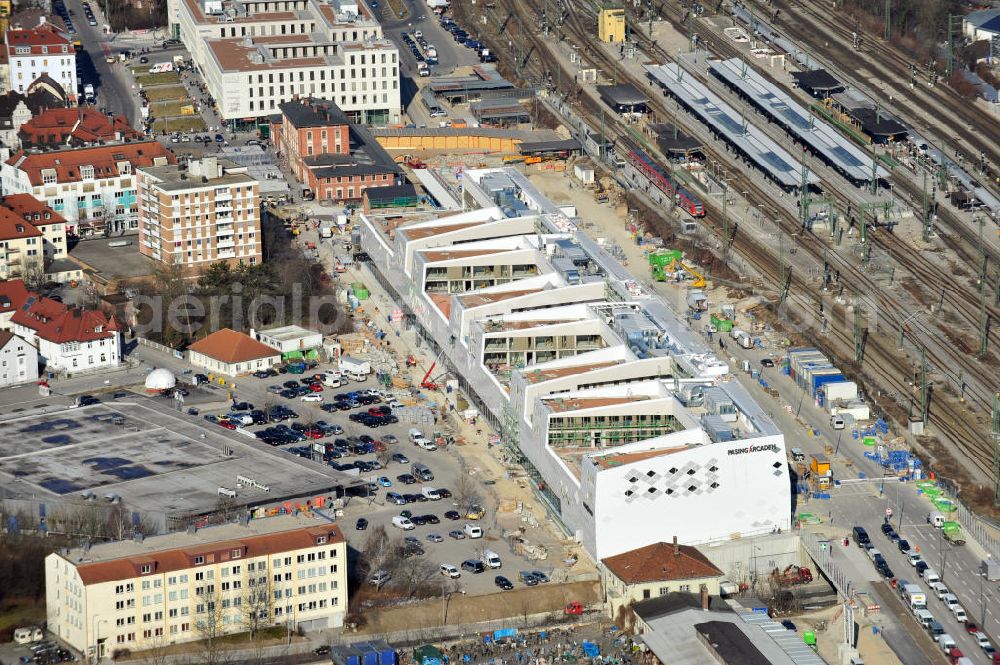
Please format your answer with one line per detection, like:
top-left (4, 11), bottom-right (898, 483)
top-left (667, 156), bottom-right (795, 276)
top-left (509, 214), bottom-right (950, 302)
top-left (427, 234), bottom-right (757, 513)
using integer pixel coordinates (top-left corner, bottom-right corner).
top-left (708, 58), bottom-right (889, 183)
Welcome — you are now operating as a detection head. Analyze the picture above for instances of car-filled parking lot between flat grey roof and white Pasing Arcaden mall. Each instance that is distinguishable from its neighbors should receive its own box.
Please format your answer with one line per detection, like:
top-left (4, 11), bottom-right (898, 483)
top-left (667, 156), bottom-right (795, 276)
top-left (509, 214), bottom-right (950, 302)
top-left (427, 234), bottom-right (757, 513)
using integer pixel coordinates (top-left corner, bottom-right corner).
top-left (186, 367), bottom-right (552, 594)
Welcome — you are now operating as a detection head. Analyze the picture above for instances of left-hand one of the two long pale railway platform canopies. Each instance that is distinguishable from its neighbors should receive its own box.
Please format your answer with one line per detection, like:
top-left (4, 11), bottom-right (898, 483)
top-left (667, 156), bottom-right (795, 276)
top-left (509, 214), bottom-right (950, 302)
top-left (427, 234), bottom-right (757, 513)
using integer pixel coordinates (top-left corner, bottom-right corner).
top-left (643, 62), bottom-right (819, 189)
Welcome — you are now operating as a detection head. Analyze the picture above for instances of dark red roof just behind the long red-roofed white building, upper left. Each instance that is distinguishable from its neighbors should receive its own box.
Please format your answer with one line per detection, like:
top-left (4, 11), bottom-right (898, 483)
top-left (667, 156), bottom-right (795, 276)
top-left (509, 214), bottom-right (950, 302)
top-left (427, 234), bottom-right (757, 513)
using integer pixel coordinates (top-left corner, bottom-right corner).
top-left (18, 106), bottom-right (141, 145)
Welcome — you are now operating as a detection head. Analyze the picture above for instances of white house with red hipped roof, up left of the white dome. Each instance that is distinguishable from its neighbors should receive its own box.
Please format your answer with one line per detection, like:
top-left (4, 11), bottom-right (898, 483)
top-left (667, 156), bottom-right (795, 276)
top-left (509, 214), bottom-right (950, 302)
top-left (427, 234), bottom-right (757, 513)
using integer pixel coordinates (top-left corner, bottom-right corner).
top-left (10, 298), bottom-right (122, 373)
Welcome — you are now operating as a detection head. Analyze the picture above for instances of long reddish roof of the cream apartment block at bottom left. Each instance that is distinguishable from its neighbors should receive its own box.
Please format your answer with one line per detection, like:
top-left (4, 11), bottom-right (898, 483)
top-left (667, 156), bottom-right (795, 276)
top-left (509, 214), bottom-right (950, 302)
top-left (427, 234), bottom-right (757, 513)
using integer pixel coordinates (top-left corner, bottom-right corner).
top-left (76, 526), bottom-right (344, 585)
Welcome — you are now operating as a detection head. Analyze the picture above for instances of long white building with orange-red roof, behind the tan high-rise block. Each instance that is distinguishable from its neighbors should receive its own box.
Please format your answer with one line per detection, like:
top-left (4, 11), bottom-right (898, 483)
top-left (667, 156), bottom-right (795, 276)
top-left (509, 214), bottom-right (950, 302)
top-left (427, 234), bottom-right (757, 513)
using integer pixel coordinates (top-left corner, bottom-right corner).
top-left (0, 141), bottom-right (177, 236)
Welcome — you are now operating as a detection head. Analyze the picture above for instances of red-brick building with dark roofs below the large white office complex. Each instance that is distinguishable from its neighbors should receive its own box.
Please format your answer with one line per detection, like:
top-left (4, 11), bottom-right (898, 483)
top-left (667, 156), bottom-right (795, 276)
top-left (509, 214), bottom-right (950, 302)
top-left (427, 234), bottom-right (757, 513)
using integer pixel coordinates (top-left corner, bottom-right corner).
top-left (271, 98), bottom-right (402, 202)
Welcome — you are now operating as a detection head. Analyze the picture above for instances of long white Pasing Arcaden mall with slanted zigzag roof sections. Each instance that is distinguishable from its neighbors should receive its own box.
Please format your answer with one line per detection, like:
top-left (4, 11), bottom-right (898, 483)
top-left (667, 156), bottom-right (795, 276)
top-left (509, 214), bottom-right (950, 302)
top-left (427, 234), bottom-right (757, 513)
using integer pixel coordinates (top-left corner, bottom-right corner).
top-left (360, 169), bottom-right (791, 559)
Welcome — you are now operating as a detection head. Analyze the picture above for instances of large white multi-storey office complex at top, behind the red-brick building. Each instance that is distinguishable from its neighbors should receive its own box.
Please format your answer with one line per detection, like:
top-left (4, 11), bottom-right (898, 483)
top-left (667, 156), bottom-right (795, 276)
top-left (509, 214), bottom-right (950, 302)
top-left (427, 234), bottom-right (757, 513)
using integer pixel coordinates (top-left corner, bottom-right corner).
top-left (167, 0), bottom-right (401, 124)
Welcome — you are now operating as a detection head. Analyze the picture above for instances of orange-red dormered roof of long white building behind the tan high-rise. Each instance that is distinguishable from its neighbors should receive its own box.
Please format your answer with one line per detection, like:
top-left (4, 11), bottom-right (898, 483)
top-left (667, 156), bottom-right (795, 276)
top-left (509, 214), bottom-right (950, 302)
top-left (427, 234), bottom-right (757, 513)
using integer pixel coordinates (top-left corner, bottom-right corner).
top-left (7, 141), bottom-right (177, 185)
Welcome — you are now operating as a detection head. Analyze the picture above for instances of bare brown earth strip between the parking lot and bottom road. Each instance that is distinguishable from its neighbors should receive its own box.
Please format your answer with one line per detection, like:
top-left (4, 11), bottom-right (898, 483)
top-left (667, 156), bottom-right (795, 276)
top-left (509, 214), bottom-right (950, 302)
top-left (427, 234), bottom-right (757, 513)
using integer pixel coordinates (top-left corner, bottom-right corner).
top-left (359, 581), bottom-right (601, 633)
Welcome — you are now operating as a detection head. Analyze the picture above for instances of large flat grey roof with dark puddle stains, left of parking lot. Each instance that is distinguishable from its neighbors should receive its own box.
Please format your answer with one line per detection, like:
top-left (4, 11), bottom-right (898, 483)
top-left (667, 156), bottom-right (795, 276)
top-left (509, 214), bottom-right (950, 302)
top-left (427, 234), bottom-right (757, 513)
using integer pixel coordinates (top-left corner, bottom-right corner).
top-left (0, 391), bottom-right (354, 517)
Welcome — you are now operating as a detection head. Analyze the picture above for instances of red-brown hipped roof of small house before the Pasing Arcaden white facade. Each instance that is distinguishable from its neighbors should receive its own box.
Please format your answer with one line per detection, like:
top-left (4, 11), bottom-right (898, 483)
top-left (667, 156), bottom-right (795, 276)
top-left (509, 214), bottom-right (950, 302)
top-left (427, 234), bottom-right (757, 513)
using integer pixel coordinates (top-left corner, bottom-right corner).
top-left (601, 543), bottom-right (722, 584)
